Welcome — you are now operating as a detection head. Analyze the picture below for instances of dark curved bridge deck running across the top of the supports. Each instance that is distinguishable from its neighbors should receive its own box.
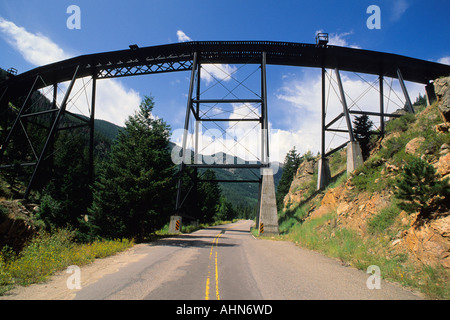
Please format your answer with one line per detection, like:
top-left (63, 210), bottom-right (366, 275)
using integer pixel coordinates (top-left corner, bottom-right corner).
top-left (0, 41), bottom-right (450, 96)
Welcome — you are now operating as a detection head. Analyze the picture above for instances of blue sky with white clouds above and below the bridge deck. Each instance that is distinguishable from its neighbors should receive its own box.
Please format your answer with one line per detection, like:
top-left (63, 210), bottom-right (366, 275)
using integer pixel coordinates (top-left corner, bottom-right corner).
top-left (0, 0), bottom-right (450, 161)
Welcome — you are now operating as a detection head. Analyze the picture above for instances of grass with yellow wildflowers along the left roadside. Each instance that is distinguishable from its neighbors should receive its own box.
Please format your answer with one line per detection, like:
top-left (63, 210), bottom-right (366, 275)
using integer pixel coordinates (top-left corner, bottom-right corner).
top-left (0, 230), bottom-right (133, 294)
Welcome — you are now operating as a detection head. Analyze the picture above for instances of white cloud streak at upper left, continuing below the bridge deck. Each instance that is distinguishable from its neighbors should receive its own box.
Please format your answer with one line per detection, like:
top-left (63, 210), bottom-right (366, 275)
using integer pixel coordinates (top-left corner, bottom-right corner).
top-left (0, 17), bottom-right (141, 125)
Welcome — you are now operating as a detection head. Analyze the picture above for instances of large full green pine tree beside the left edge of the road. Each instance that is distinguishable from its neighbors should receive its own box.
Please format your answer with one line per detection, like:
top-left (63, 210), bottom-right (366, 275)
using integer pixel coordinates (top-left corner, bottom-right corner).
top-left (89, 97), bottom-right (175, 240)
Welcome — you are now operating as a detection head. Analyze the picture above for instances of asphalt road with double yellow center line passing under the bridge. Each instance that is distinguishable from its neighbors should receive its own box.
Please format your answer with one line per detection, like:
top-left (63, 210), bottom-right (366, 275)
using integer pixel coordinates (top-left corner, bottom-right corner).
top-left (75, 221), bottom-right (420, 300)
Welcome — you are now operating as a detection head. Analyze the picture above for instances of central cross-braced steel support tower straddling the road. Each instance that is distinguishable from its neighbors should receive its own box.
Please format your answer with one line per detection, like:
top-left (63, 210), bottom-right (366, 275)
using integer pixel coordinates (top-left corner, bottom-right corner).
top-left (175, 52), bottom-right (278, 232)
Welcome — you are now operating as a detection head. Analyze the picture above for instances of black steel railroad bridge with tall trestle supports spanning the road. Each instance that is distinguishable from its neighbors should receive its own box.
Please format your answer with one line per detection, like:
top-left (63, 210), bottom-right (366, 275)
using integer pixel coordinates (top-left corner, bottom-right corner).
top-left (0, 38), bottom-right (450, 233)
